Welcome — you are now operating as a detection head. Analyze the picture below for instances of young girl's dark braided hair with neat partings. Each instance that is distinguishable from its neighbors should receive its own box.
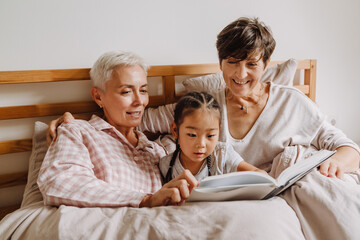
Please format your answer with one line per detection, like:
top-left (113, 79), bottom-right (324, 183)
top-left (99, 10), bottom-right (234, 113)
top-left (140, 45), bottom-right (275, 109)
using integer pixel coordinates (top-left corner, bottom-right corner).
top-left (164, 92), bottom-right (220, 184)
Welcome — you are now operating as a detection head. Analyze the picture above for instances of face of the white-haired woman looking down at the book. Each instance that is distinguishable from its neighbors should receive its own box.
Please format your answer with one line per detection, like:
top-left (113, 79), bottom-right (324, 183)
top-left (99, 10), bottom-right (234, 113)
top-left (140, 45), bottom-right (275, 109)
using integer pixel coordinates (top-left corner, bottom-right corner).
top-left (91, 66), bottom-right (149, 133)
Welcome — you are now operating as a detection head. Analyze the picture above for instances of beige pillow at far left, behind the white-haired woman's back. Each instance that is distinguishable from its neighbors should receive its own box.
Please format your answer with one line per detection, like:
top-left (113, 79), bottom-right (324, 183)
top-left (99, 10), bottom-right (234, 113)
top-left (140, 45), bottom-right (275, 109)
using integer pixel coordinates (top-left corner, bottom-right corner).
top-left (21, 121), bottom-right (48, 207)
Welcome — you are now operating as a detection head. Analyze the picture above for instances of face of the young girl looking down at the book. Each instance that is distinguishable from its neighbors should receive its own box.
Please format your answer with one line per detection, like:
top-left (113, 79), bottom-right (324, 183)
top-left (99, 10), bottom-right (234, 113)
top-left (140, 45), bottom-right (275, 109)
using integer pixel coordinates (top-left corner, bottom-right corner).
top-left (172, 109), bottom-right (220, 172)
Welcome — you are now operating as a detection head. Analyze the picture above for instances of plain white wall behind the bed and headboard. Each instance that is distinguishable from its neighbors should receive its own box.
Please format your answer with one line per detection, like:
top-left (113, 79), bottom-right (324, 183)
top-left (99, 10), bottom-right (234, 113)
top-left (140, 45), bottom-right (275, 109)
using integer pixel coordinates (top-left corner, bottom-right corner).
top-left (0, 0), bottom-right (360, 206)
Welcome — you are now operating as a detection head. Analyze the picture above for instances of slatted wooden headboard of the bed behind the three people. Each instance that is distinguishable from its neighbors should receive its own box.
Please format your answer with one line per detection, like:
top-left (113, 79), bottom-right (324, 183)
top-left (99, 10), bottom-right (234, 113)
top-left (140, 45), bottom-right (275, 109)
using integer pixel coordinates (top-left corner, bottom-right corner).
top-left (0, 59), bottom-right (316, 219)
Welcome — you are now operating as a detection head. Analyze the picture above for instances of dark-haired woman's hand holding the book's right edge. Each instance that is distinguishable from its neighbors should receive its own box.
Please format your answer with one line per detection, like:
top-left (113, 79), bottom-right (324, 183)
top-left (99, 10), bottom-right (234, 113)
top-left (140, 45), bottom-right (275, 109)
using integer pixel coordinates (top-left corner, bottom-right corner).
top-left (319, 146), bottom-right (360, 179)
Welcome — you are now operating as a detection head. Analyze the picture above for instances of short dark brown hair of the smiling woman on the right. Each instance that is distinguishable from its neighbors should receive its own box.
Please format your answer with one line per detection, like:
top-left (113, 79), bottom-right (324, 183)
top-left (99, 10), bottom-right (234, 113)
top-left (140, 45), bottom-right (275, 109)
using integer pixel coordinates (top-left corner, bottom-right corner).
top-left (216, 18), bottom-right (276, 66)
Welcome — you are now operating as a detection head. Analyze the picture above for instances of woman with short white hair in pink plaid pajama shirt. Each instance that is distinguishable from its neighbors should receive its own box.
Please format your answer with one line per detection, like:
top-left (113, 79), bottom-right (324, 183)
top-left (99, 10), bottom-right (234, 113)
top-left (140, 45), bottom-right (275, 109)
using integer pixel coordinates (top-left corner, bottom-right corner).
top-left (38, 51), bottom-right (198, 207)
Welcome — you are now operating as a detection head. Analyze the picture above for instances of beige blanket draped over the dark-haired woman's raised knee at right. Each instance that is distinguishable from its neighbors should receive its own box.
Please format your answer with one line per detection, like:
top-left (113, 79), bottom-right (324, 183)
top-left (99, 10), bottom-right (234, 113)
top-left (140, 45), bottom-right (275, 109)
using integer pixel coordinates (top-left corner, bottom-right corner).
top-left (270, 146), bottom-right (360, 239)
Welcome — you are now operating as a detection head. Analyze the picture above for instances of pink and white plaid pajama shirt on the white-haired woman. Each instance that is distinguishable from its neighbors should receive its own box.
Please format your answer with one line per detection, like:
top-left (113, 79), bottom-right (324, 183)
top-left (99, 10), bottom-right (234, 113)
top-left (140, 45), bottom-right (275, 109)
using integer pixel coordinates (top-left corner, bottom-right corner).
top-left (38, 115), bottom-right (165, 207)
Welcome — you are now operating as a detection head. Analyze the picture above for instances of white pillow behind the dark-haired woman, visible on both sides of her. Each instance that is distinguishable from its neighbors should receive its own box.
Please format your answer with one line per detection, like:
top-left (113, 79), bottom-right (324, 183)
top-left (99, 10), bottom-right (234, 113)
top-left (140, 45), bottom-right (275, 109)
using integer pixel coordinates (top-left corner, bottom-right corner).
top-left (182, 59), bottom-right (297, 92)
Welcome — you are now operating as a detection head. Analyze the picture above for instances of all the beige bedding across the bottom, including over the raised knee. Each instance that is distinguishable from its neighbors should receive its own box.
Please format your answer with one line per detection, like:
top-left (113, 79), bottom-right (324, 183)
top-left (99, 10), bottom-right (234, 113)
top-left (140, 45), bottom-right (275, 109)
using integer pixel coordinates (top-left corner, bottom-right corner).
top-left (0, 147), bottom-right (360, 239)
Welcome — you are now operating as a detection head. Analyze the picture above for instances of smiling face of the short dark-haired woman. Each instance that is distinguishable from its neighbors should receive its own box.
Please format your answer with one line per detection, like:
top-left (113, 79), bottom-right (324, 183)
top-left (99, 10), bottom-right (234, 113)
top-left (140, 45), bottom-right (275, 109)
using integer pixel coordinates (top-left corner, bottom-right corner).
top-left (220, 53), bottom-right (266, 97)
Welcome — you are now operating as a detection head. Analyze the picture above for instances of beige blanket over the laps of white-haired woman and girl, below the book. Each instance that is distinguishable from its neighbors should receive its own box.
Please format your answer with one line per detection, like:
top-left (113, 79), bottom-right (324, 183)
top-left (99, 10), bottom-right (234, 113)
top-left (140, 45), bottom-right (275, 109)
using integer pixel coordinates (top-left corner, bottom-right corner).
top-left (0, 197), bottom-right (304, 239)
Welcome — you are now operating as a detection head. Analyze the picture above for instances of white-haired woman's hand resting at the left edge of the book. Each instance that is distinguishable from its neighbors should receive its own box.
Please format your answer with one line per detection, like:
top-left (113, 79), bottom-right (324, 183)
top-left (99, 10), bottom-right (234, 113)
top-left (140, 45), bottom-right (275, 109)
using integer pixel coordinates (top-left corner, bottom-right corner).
top-left (140, 170), bottom-right (199, 207)
